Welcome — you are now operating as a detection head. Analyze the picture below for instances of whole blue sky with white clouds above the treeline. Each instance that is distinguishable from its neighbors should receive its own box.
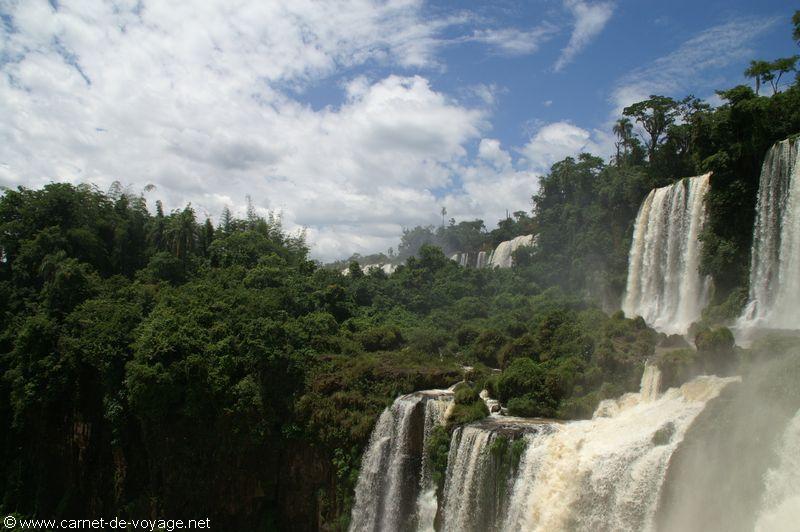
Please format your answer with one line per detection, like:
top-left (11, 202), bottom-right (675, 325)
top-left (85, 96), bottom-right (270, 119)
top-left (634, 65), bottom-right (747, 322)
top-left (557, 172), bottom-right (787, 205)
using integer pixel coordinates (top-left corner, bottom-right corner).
top-left (0, 0), bottom-right (800, 261)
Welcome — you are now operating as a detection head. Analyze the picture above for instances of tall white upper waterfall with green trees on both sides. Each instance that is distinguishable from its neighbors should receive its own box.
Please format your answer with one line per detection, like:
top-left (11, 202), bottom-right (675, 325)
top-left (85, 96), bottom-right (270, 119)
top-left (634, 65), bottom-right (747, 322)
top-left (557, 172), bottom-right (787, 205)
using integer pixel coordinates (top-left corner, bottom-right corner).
top-left (622, 174), bottom-right (710, 333)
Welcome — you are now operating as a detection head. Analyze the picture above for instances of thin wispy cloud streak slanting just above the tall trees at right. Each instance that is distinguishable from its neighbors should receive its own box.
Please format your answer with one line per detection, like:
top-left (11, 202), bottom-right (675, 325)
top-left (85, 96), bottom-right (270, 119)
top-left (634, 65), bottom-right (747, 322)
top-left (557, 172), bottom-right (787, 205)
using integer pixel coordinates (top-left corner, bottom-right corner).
top-left (611, 18), bottom-right (777, 116)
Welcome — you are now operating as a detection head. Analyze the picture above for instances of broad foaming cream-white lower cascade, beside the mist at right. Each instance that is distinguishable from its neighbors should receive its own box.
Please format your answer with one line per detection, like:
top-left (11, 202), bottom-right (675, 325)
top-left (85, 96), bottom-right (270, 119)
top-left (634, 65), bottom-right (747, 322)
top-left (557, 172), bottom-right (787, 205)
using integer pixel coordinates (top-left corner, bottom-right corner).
top-left (503, 370), bottom-right (734, 531)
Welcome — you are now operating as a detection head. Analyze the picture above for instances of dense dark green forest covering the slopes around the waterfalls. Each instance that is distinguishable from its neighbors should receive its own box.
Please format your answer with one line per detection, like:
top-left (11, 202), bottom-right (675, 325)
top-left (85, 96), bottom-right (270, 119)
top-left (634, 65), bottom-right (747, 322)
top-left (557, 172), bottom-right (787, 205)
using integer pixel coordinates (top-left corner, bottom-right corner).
top-left (0, 11), bottom-right (800, 530)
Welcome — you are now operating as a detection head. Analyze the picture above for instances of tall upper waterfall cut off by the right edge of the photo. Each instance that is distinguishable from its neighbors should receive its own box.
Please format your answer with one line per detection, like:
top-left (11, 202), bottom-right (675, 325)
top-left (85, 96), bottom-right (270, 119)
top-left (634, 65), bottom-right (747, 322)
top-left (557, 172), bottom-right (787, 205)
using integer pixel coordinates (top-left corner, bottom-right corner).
top-left (740, 140), bottom-right (800, 329)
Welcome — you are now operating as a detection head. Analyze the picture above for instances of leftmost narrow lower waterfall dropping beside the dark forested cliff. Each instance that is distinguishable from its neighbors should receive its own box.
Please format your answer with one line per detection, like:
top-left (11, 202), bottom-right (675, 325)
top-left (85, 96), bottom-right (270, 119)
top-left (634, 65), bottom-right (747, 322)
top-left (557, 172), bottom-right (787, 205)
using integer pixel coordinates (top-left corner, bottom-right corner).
top-left (350, 390), bottom-right (452, 532)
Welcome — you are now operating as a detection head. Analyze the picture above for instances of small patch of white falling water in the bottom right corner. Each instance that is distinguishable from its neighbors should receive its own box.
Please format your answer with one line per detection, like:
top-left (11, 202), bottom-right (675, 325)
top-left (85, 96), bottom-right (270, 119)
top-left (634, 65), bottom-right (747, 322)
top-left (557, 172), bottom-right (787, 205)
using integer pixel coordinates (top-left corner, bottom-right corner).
top-left (755, 411), bottom-right (800, 532)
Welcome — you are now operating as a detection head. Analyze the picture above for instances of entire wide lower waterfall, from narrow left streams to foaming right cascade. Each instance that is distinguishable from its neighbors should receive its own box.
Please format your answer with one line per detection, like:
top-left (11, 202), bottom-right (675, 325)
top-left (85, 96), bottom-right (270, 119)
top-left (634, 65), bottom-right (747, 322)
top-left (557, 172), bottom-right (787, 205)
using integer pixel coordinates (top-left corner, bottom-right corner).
top-left (351, 365), bottom-right (744, 532)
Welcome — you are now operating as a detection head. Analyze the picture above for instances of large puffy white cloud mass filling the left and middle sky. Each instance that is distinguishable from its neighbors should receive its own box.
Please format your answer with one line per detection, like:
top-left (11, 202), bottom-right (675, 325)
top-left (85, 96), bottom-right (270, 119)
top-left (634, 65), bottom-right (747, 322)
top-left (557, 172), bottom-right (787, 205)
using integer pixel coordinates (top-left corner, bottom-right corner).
top-left (0, 0), bottom-right (556, 259)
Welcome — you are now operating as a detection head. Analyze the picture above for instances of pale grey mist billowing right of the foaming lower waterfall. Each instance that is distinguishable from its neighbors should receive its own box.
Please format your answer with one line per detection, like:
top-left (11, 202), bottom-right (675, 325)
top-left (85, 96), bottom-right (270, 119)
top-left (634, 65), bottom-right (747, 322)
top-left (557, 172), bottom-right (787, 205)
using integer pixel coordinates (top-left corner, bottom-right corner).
top-left (657, 339), bottom-right (800, 532)
